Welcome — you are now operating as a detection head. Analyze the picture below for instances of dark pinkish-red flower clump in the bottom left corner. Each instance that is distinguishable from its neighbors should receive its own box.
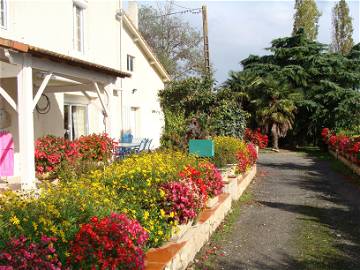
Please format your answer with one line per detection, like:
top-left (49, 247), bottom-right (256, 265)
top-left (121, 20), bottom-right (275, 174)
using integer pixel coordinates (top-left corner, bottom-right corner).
top-left (0, 236), bottom-right (62, 270)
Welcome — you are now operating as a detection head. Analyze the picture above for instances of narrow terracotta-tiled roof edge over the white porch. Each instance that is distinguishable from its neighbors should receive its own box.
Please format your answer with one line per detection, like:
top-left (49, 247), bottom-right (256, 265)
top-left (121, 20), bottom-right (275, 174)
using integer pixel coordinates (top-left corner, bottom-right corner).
top-left (0, 37), bottom-right (131, 78)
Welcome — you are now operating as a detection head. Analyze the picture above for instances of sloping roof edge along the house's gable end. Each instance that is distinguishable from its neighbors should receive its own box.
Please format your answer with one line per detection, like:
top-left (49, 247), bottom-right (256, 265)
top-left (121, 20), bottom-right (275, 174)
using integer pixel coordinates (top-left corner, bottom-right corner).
top-left (122, 13), bottom-right (170, 82)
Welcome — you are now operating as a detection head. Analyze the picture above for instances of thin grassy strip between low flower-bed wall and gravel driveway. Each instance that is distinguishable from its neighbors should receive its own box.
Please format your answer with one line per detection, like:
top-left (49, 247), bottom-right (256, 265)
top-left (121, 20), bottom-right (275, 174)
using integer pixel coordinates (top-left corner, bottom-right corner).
top-left (191, 191), bottom-right (253, 270)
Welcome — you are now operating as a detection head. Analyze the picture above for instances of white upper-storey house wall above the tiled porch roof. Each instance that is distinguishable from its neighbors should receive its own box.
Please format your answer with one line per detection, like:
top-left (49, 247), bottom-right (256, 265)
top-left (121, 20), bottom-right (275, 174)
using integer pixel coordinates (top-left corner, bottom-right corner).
top-left (0, 0), bottom-right (120, 69)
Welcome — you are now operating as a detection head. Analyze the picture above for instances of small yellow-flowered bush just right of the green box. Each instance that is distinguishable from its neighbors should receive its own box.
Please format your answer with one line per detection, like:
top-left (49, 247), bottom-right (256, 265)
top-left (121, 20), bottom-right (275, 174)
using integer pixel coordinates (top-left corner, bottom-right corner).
top-left (212, 136), bottom-right (246, 168)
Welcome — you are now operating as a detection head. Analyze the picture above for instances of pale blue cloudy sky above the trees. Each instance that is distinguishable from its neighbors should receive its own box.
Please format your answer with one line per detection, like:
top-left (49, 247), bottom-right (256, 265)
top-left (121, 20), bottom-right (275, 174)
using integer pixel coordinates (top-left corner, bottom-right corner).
top-left (140, 0), bottom-right (360, 83)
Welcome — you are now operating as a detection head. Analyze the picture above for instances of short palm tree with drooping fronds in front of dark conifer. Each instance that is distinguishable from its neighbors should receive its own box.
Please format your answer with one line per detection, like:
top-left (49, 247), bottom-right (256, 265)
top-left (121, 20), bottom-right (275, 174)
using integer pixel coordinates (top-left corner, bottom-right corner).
top-left (252, 78), bottom-right (299, 150)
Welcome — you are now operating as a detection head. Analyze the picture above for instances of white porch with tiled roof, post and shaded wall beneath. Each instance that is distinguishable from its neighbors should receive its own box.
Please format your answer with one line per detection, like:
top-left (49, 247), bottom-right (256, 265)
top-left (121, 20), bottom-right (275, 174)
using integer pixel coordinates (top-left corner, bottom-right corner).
top-left (0, 38), bottom-right (130, 190)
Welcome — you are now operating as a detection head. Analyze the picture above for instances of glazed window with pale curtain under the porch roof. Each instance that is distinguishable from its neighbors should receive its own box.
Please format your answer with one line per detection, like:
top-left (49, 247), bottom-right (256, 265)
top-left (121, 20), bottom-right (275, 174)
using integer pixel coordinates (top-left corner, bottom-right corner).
top-left (64, 104), bottom-right (88, 140)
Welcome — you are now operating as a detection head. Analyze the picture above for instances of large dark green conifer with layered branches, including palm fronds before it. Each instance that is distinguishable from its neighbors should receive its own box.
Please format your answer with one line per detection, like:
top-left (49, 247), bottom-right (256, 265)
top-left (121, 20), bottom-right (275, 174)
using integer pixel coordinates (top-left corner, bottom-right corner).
top-left (227, 31), bottom-right (360, 145)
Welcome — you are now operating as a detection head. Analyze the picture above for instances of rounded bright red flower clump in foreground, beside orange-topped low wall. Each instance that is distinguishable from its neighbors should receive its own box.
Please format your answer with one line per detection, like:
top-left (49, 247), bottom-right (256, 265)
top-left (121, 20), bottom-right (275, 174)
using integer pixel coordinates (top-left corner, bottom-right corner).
top-left (69, 213), bottom-right (148, 270)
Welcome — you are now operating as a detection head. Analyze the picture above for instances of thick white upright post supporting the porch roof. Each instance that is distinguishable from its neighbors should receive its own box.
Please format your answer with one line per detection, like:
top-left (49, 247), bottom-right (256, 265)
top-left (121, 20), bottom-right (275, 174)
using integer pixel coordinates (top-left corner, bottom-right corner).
top-left (17, 55), bottom-right (36, 190)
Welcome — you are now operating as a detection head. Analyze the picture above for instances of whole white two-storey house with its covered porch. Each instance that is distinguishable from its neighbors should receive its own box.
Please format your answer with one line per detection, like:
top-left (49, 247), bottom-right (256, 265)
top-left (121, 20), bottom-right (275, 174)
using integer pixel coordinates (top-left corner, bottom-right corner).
top-left (0, 0), bottom-right (169, 189)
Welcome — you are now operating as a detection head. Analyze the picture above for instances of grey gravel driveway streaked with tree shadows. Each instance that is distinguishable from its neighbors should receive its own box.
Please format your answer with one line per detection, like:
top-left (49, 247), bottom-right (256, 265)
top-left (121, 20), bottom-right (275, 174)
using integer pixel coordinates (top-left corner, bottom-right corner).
top-left (192, 151), bottom-right (360, 270)
